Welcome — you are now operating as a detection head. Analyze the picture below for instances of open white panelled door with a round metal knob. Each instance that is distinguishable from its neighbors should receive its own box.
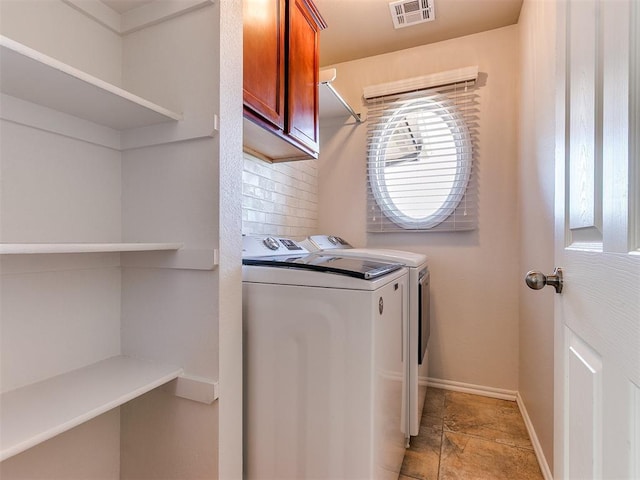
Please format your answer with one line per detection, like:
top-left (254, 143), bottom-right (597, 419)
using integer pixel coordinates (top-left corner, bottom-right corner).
top-left (554, 0), bottom-right (640, 479)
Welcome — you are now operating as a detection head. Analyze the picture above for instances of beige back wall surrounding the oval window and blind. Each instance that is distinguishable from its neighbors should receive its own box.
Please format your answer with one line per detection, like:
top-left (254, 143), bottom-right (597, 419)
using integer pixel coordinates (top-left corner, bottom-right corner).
top-left (318, 26), bottom-right (522, 391)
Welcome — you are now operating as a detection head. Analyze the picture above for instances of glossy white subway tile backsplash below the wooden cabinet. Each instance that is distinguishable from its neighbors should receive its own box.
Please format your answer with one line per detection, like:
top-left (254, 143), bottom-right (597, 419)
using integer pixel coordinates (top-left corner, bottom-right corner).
top-left (242, 154), bottom-right (318, 239)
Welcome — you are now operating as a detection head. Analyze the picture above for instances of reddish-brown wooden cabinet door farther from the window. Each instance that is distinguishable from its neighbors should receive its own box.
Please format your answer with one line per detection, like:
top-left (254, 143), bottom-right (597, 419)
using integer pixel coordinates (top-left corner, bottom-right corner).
top-left (243, 0), bottom-right (286, 130)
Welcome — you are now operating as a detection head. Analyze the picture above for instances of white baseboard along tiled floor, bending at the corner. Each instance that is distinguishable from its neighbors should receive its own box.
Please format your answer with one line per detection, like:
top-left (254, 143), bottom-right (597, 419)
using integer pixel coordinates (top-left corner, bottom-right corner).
top-left (418, 377), bottom-right (553, 480)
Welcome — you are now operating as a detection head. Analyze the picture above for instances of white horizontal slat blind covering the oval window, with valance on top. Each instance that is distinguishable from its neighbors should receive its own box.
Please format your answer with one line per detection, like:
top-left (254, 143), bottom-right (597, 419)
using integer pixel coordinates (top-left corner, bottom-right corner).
top-left (365, 67), bottom-right (478, 232)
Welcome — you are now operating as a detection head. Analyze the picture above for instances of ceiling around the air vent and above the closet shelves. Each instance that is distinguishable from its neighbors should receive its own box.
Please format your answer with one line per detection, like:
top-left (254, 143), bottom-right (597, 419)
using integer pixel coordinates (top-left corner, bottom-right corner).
top-left (102, 0), bottom-right (522, 66)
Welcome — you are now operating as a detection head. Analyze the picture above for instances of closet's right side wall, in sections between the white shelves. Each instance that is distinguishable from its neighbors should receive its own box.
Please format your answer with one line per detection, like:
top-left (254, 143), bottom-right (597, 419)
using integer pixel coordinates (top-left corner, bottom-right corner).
top-left (120, 6), bottom-right (225, 480)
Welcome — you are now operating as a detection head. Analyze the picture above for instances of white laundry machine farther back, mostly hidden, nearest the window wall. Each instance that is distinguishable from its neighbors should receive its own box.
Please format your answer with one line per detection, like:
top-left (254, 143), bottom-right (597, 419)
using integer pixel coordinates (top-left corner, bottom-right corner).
top-left (300, 235), bottom-right (430, 445)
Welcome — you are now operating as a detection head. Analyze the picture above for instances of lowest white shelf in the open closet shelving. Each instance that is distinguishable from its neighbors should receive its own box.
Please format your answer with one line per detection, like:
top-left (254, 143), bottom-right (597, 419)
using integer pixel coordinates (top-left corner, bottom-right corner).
top-left (0, 356), bottom-right (182, 461)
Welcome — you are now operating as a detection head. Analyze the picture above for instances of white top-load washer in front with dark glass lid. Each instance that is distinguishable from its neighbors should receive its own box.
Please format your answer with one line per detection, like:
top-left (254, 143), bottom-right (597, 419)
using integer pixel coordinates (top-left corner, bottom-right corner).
top-left (242, 236), bottom-right (408, 480)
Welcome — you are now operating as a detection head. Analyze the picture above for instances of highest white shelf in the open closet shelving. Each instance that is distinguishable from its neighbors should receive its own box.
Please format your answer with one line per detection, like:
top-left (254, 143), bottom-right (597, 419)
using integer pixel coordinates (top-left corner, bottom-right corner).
top-left (0, 35), bottom-right (183, 130)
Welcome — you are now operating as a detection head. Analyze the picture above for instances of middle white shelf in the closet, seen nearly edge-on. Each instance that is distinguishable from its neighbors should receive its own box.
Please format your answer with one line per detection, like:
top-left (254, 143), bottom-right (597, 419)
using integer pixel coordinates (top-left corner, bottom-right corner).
top-left (0, 243), bottom-right (183, 255)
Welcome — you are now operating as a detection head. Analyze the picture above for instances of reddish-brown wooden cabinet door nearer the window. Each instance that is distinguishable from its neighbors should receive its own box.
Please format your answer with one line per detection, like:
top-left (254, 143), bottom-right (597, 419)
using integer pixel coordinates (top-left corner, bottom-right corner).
top-left (286, 0), bottom-right (320, 152)
